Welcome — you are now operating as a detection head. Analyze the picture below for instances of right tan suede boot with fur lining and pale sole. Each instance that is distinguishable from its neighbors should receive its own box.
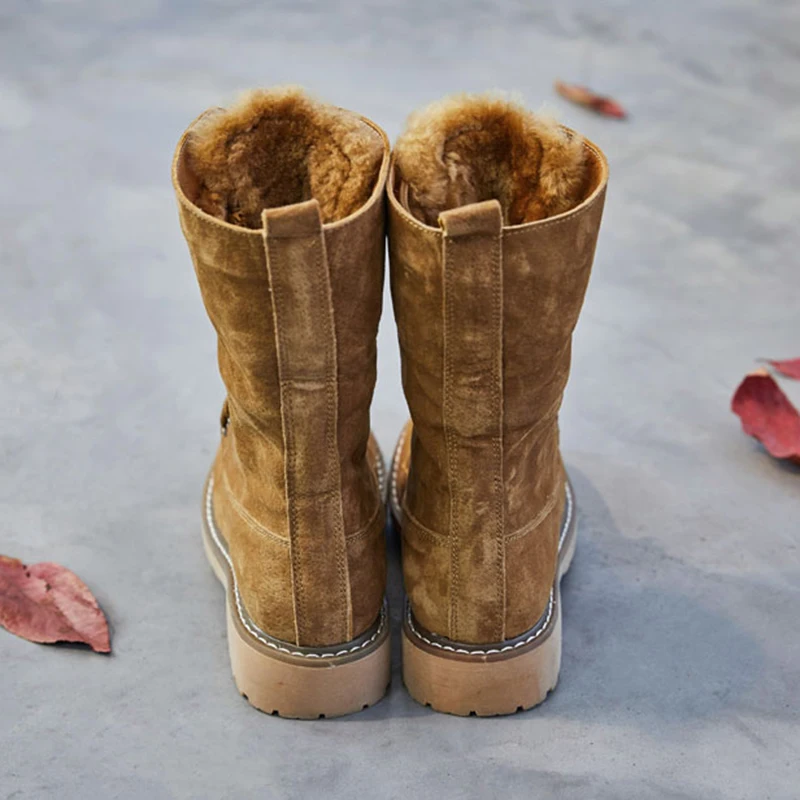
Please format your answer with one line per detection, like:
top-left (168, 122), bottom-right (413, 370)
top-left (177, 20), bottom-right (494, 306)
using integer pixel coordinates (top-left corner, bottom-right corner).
top-left (388, 97), bottom-right (607, 716)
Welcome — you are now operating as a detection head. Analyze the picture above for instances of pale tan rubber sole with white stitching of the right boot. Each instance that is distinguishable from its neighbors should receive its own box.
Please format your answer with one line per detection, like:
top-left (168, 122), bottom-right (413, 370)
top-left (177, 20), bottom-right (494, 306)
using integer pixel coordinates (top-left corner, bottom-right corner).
top-left (393, 472), bottom-right (576, 717)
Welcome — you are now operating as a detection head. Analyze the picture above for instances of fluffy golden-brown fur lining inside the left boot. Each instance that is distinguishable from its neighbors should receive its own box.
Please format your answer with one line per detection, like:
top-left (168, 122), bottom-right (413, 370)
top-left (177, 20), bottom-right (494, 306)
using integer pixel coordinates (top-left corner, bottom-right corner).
top-left (184, 87), bottom-right (384, 228)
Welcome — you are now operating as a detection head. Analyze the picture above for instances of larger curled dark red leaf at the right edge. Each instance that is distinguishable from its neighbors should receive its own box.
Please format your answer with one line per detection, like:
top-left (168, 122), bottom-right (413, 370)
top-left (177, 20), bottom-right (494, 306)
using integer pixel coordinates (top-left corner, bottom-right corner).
top-left (731, 369), bottom-right (800, 463)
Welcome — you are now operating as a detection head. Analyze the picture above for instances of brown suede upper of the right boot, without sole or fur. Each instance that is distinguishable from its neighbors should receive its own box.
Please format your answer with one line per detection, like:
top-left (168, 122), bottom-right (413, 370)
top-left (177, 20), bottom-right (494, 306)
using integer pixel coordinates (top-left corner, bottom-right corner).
top-left (388, 98), bottom-right (607, 644)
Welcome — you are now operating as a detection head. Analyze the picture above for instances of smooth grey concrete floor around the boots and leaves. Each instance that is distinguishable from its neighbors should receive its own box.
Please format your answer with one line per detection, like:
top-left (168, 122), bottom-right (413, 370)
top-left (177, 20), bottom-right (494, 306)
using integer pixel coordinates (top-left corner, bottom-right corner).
top-left (0, 0), bottom-right (800, 800)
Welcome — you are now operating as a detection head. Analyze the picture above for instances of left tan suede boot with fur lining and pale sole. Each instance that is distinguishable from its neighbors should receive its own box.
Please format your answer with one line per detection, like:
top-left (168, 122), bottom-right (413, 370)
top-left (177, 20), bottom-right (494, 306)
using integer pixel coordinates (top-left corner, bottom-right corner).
top-left (172, 89), bottom-right (390, 718)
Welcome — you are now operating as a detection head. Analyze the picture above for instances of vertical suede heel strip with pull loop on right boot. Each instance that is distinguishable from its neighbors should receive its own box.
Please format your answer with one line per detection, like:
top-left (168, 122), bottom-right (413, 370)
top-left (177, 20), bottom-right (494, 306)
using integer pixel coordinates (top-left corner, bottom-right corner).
top-left (439, 200), bottom-right (505, 642)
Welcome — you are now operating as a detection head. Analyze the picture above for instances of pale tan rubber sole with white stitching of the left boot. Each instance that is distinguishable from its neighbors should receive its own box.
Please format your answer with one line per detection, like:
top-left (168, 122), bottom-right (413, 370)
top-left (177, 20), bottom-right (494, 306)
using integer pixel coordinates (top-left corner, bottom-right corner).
top-left (202, 479), bottom-right (391, 719)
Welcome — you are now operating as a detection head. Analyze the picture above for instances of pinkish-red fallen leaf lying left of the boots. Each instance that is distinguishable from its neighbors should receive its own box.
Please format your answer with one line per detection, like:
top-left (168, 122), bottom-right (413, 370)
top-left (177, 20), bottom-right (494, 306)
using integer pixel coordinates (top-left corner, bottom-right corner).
top-left (0, 555), bottom-right (111, 653)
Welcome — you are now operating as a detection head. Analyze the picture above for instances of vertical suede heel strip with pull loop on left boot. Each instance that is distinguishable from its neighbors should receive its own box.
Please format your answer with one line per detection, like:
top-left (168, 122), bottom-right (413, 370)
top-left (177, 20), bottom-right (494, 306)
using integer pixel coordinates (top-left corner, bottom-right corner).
top-left (262, 200), bottom-right (353, 643)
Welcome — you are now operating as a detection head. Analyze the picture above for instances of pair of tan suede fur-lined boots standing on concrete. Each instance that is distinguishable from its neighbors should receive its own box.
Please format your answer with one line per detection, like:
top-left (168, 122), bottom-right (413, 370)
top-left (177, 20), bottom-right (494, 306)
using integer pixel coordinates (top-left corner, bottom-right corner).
top-left (173, 89), bottom-right (607, 718)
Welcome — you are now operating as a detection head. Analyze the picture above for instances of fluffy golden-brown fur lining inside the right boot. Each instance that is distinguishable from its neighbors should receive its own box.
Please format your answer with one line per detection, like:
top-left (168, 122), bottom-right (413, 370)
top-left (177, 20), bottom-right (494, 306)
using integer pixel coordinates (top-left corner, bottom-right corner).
top-left (395, 95), bottom-right (591, 225)
